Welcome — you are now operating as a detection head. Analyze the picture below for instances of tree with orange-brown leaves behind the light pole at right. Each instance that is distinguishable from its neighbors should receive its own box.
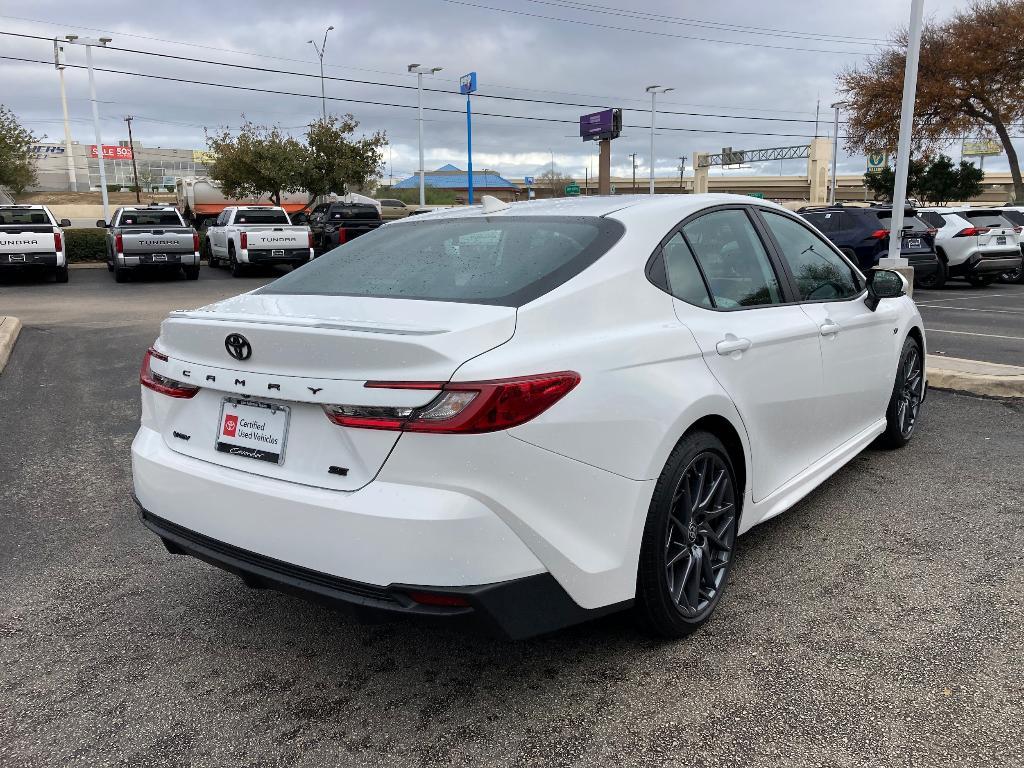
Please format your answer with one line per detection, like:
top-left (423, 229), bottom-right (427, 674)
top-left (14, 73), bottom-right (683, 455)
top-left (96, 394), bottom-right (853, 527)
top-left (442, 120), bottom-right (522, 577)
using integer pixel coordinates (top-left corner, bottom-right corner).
top-left (839, 0), bottom-right (1024, 202)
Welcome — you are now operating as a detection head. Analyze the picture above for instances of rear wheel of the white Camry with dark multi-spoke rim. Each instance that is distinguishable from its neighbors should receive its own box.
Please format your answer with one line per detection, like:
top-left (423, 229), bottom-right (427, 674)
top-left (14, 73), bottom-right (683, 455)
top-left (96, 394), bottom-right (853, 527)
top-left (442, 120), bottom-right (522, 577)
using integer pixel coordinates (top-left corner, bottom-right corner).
top-left (634, 432), bottom-right (742, 638)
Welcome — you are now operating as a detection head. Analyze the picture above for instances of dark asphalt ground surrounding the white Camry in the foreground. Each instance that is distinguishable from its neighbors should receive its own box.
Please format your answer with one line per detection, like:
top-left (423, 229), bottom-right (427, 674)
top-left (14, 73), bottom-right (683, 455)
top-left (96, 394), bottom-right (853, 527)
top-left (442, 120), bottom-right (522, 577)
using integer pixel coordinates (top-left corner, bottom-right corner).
top-left (0, 268), bottom-right (1024, 767)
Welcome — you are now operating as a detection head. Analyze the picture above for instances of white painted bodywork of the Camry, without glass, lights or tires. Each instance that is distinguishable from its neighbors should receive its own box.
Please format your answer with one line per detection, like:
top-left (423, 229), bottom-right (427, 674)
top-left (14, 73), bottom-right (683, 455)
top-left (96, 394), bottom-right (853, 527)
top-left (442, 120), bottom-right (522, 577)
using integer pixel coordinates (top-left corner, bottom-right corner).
top-left (132, 195), bottom-right (923, 634)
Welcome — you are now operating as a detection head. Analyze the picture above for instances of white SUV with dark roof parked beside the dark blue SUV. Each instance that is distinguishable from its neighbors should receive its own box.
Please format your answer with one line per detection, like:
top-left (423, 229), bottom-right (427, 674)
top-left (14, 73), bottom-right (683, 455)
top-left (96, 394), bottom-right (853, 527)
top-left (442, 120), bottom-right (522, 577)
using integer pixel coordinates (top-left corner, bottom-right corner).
top-left (918, 207), bottom-right (1021, 288)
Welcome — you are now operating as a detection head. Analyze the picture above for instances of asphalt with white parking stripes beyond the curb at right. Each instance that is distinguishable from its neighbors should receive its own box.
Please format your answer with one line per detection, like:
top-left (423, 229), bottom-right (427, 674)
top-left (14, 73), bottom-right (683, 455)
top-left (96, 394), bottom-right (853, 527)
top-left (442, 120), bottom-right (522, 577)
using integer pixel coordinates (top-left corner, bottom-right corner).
top-left (913, 280), bottom-right (1024, 366)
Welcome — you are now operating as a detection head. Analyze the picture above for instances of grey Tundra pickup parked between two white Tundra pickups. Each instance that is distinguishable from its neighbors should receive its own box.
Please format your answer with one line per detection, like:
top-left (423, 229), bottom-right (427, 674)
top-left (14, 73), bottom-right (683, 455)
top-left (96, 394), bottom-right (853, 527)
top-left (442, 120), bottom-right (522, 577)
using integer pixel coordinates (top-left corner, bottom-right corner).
top-left (102, 205), bottom-right (199, 283)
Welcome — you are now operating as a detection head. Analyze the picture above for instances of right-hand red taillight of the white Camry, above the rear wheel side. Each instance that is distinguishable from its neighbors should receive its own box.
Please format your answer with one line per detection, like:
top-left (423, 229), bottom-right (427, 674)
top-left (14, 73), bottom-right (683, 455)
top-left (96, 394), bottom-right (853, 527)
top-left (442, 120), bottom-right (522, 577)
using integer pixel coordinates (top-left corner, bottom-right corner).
top-left (324, 371), bottom-right (580, 434)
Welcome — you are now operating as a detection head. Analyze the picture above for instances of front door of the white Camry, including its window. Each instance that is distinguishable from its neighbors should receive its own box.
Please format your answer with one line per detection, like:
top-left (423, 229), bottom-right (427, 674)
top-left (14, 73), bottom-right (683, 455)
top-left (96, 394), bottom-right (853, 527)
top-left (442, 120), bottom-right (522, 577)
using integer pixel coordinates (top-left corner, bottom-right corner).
top-left (760, 209), bottom-right (898, 456)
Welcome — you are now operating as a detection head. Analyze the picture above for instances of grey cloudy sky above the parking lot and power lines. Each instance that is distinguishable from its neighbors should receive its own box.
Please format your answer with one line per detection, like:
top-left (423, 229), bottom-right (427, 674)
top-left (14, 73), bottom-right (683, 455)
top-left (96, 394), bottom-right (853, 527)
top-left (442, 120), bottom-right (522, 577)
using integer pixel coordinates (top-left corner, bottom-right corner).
top-left (0, 0), bottom-right (991, 180)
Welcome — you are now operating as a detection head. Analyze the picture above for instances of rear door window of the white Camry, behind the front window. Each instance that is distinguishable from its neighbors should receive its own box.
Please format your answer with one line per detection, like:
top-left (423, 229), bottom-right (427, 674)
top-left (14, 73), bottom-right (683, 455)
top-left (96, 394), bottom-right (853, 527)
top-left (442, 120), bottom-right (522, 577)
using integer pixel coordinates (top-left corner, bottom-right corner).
top-left (683, 209), bottom-right (782, 309)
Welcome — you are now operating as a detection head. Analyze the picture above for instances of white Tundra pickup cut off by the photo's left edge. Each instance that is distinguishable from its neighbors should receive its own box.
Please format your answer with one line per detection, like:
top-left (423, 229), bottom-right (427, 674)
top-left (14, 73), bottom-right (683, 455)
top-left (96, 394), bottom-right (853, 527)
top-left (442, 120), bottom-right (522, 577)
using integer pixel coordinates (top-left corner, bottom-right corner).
top-left (0, 205), bottom-right (71, 283)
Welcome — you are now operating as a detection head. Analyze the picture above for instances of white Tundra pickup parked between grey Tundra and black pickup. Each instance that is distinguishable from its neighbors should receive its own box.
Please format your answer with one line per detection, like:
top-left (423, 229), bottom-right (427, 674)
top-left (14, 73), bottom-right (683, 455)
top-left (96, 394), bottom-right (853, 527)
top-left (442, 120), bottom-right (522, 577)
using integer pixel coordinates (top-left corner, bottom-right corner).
top-left (204, 206), bottom-right (313, 278)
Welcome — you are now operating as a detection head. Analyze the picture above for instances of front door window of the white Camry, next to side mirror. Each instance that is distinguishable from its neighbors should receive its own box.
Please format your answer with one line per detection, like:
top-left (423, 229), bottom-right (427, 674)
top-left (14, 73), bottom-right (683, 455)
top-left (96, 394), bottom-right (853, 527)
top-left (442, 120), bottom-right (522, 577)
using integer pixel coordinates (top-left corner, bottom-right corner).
top-left (761, 210), bottom-right (860, 301)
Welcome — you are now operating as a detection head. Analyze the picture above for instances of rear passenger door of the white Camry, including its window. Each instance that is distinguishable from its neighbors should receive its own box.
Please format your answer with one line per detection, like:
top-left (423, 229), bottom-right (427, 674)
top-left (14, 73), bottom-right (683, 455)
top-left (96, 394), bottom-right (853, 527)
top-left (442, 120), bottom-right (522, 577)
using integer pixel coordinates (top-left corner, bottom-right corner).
top-left (666, 207), bottom-right (823, 501)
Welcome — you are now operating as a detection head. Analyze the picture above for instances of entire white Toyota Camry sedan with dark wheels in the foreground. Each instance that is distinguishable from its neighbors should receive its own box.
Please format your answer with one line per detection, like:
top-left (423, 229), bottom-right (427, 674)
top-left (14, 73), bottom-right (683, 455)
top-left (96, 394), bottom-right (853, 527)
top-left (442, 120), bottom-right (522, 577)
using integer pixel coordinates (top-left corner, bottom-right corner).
top-left (132, 195), bottom-right (926, 637)
